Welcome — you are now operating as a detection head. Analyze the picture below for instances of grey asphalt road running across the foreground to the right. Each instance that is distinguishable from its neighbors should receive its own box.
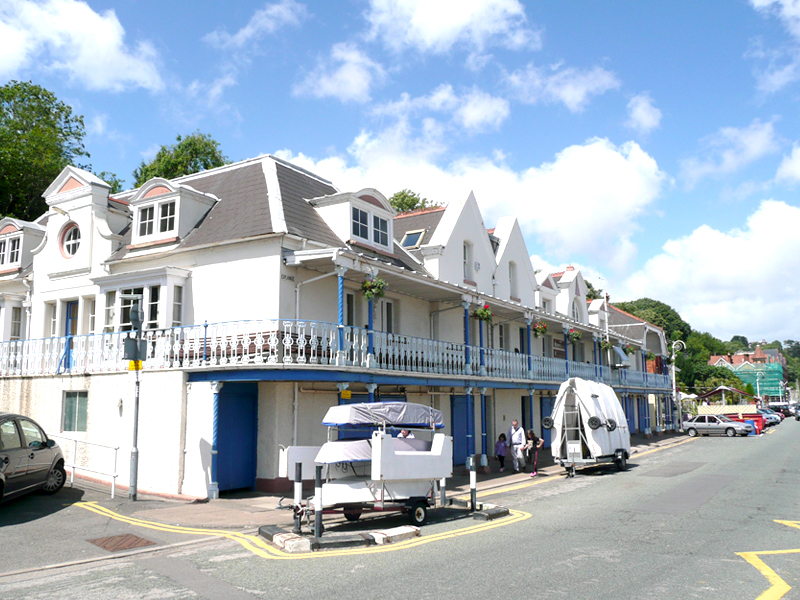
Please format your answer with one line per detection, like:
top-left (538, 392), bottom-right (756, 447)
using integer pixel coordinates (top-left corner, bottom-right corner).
top-left (0, 421), bottom-right (800, 600)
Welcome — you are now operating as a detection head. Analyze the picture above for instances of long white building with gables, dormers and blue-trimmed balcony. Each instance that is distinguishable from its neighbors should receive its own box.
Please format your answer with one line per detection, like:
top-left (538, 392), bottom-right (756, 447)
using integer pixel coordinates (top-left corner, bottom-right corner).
top-left (0, 156), bottom-right (670, 497)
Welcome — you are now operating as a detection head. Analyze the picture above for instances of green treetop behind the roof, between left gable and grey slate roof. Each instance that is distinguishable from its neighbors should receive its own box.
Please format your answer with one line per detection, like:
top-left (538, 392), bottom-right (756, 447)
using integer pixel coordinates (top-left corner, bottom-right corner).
top-left (133, 131), bottom-right (230, 187)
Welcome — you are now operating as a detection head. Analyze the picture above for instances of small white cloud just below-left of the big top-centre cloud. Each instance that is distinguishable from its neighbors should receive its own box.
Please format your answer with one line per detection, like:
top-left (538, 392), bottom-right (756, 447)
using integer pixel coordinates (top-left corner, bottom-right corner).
top-left (293, 43), bottom-right (386, 103)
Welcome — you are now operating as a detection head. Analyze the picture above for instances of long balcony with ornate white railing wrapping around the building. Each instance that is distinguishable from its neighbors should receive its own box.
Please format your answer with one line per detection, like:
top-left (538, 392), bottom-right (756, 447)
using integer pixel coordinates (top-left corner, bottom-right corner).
top-left (0, 319), bottom-right (670, 390)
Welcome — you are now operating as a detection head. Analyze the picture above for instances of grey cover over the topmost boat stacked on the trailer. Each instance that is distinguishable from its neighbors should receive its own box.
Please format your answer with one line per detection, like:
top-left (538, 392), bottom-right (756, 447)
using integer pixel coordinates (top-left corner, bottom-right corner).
top-left (322, 402), bottom-right (444, 429)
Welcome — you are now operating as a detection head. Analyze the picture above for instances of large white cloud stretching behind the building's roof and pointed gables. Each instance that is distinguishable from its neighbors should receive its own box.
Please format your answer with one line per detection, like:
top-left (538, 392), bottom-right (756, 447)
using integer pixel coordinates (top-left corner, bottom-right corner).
top-left (281, 130), bottom-right (666, 270)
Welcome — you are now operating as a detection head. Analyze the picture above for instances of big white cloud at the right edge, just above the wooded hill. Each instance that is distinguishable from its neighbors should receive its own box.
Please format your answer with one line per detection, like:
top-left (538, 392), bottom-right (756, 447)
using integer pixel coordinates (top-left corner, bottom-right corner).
top-left (621, 200), bottom-right (800, 340)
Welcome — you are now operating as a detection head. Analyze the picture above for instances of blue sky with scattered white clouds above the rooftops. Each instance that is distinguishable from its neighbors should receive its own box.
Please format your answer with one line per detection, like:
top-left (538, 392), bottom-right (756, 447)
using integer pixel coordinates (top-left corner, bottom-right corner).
top-left (0, 0), bottom-right (800, 341)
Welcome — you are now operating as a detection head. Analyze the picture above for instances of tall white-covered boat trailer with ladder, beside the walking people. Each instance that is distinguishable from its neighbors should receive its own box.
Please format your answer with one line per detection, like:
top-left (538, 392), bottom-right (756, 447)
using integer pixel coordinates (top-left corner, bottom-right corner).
top-left (542, 377), bottom-right (631, 477)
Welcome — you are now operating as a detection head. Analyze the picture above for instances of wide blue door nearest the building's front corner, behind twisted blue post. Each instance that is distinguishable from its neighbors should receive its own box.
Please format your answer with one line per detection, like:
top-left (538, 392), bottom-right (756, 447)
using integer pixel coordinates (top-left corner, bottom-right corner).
top-left (217, 381), bottom-right (258, 492)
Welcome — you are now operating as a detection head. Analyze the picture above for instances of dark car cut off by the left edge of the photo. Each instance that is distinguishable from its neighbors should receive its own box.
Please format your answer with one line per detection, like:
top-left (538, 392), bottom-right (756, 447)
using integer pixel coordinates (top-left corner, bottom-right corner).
top-left (0, 412), bottom-right (67, 501)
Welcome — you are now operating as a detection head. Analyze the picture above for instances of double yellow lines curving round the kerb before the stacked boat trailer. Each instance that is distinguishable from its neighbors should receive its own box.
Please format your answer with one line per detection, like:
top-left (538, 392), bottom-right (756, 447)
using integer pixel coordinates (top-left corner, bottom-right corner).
top-left (75, 502), bottom-right (531, 560)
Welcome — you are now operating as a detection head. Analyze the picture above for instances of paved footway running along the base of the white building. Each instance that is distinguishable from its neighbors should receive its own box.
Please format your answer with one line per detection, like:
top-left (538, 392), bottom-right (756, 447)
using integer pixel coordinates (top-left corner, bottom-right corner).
top-left (76, 432), bottom-right (687, 530)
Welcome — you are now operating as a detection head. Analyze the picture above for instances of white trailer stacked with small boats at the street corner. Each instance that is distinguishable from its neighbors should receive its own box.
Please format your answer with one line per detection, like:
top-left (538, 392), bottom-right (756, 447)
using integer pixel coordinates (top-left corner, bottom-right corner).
top-left (279, 402), bottom-right (453, 525)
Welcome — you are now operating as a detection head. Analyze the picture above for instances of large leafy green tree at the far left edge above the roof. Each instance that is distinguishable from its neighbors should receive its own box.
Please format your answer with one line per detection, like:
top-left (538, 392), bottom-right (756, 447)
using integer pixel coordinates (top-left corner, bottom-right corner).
top-left (0, 81), bottom-right (89, 221)
